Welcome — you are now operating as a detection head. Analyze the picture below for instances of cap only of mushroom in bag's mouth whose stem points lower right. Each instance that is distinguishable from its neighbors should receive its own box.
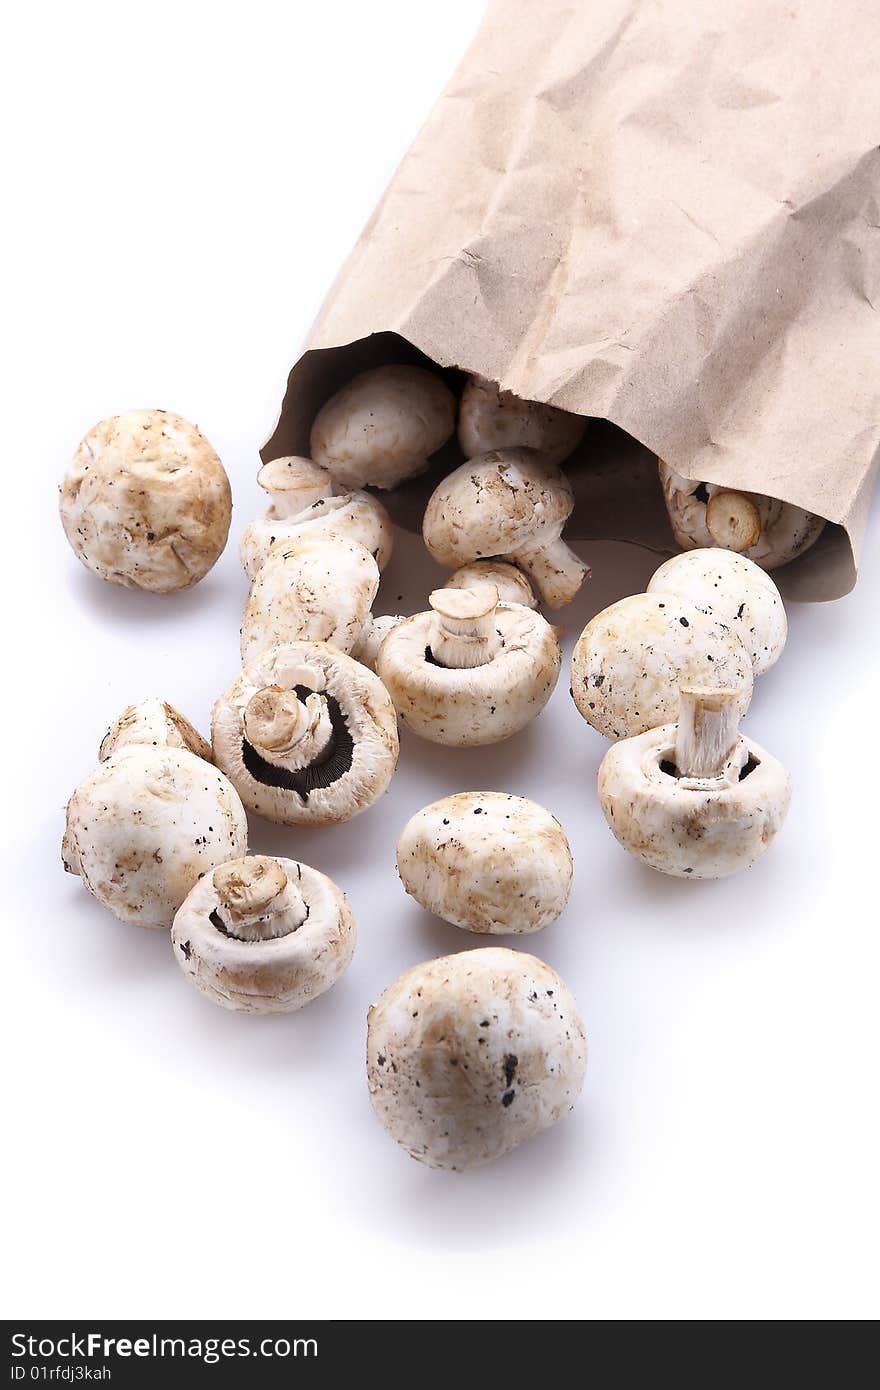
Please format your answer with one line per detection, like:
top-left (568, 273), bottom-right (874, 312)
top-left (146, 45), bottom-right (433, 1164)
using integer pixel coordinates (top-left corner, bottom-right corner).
top-left (421, 449), bottom-right (574, 569)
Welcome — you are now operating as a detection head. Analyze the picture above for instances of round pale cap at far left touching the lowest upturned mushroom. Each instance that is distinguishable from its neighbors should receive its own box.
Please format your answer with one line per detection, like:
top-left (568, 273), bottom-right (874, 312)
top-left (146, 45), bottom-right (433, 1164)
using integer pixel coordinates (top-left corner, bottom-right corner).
top-left (64, 745), bottom-right (247, 927)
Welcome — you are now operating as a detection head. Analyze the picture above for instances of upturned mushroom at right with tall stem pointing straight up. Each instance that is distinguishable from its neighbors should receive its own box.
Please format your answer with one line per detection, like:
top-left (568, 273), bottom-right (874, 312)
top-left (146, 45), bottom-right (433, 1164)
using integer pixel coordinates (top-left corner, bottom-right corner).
top-left (599, 687), bottom-right (791, 878)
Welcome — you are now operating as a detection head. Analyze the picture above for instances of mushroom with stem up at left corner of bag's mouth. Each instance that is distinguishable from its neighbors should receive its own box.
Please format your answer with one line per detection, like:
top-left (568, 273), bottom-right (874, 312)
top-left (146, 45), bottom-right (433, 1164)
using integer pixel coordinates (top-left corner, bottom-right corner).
top-left (239, 456), bottom-right (393, 580)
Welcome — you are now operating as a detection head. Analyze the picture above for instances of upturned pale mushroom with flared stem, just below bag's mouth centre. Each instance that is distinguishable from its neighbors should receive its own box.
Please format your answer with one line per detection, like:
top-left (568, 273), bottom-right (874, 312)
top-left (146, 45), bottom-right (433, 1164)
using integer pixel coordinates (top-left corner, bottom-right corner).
top-left (377, 584), bottom-right (562, 748)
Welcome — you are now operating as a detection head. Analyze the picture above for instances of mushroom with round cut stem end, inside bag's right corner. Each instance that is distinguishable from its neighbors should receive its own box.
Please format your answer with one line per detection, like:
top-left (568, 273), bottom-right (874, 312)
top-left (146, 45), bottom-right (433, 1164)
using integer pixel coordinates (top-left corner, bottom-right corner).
top-left (658, 460), bottom-right (826, 570)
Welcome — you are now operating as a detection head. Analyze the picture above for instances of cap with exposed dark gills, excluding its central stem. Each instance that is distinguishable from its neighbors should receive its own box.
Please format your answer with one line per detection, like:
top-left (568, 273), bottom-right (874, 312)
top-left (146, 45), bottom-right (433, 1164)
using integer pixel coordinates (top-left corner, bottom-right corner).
top-left (211, 642), bottom-right (399, 826)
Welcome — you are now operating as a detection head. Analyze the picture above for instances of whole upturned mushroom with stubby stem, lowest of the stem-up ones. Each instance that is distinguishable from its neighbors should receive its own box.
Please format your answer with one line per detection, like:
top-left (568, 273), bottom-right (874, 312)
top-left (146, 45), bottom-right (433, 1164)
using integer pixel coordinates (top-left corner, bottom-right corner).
top-left (171, 855), bottom-right (356, 1013)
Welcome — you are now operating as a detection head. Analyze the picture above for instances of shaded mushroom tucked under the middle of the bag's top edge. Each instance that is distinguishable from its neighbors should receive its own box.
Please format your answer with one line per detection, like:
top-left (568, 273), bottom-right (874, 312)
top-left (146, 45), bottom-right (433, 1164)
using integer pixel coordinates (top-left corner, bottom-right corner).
top-left (459, 377), bottom-right (587, 463)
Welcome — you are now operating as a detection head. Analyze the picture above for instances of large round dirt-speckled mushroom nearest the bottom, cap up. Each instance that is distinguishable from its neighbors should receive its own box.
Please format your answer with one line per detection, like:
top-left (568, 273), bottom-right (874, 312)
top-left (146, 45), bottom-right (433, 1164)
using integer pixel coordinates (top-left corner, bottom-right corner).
top-left (367, 947), bottom-right (587, 1169)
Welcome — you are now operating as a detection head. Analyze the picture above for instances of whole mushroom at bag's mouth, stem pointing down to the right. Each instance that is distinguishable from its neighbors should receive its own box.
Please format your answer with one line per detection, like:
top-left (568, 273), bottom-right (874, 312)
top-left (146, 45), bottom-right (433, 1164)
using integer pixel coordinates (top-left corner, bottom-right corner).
top-left (423, 449), bottom-right (589, 607)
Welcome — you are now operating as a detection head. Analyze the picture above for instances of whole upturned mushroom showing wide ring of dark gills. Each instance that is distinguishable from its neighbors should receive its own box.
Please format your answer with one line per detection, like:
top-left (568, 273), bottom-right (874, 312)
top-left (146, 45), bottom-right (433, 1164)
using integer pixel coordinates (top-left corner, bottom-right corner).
top-left (211, 642), bottom-right (398, 826)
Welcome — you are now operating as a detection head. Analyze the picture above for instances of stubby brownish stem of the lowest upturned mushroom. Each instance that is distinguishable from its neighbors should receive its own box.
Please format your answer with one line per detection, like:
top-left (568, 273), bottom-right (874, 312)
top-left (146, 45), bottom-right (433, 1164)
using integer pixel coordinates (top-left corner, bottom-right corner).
top-left (214, 855), bottom-right (309, 941)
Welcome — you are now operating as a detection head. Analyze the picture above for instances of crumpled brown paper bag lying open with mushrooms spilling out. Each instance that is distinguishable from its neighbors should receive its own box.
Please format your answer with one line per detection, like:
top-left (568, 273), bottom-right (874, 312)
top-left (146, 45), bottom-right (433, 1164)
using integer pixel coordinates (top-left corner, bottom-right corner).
top-left (263, 0), bottom-right (880, 599)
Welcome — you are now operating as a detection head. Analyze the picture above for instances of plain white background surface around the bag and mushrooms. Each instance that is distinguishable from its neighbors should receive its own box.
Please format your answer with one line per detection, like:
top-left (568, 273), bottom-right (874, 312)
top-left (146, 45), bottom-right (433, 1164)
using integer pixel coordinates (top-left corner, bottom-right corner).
top-left (0, 0), bottom-right (880, 1319)
